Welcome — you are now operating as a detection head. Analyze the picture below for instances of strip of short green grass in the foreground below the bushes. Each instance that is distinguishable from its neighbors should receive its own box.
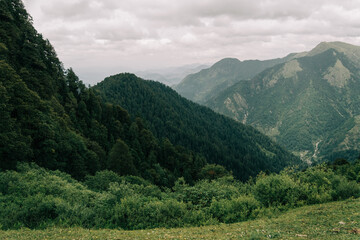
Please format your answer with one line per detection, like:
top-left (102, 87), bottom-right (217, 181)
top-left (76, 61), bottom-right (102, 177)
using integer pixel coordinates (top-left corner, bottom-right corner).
top-left (0, 199), bottom-right (360, 240)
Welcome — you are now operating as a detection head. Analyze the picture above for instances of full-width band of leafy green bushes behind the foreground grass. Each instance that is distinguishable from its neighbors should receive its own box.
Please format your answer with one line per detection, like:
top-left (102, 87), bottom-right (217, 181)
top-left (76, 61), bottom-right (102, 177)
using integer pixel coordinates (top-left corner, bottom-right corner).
top-left (0, 164), bottom-right (360, 229)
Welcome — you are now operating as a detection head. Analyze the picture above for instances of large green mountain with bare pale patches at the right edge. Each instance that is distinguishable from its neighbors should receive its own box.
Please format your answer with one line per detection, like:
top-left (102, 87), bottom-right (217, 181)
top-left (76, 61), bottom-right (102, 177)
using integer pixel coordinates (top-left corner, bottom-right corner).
top-left (206, 42), bottom-right (360, 161)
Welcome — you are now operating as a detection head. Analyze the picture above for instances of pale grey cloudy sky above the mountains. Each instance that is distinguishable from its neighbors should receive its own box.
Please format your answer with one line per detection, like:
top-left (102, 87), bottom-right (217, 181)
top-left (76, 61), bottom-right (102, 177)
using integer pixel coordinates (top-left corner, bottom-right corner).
top-left (23, 0), bottom-right (360, 84)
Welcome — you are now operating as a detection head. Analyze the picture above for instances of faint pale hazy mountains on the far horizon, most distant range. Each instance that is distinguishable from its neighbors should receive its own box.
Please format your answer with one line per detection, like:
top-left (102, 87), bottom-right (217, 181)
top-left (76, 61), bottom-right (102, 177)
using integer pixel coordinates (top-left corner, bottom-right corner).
top-left (136, 64), bottom-right (209, 86)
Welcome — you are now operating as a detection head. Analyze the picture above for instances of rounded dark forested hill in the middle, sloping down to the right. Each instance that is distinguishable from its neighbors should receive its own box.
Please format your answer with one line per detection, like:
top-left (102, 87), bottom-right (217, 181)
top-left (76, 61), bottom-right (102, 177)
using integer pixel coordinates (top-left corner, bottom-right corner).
top-left (94, 74), bottom-right (299, 180)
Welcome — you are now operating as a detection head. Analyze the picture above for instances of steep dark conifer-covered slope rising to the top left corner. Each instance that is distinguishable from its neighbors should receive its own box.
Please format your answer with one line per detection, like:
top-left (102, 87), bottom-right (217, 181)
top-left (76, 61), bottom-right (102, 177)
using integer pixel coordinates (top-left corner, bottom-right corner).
top-left (0, 0), bottom-right (206, 185)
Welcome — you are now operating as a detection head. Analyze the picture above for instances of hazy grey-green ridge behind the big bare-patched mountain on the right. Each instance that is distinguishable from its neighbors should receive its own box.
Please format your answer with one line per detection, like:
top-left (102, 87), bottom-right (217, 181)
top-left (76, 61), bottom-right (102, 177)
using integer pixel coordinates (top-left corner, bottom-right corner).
top-left (174, 54), bottom-right (294, 103)
